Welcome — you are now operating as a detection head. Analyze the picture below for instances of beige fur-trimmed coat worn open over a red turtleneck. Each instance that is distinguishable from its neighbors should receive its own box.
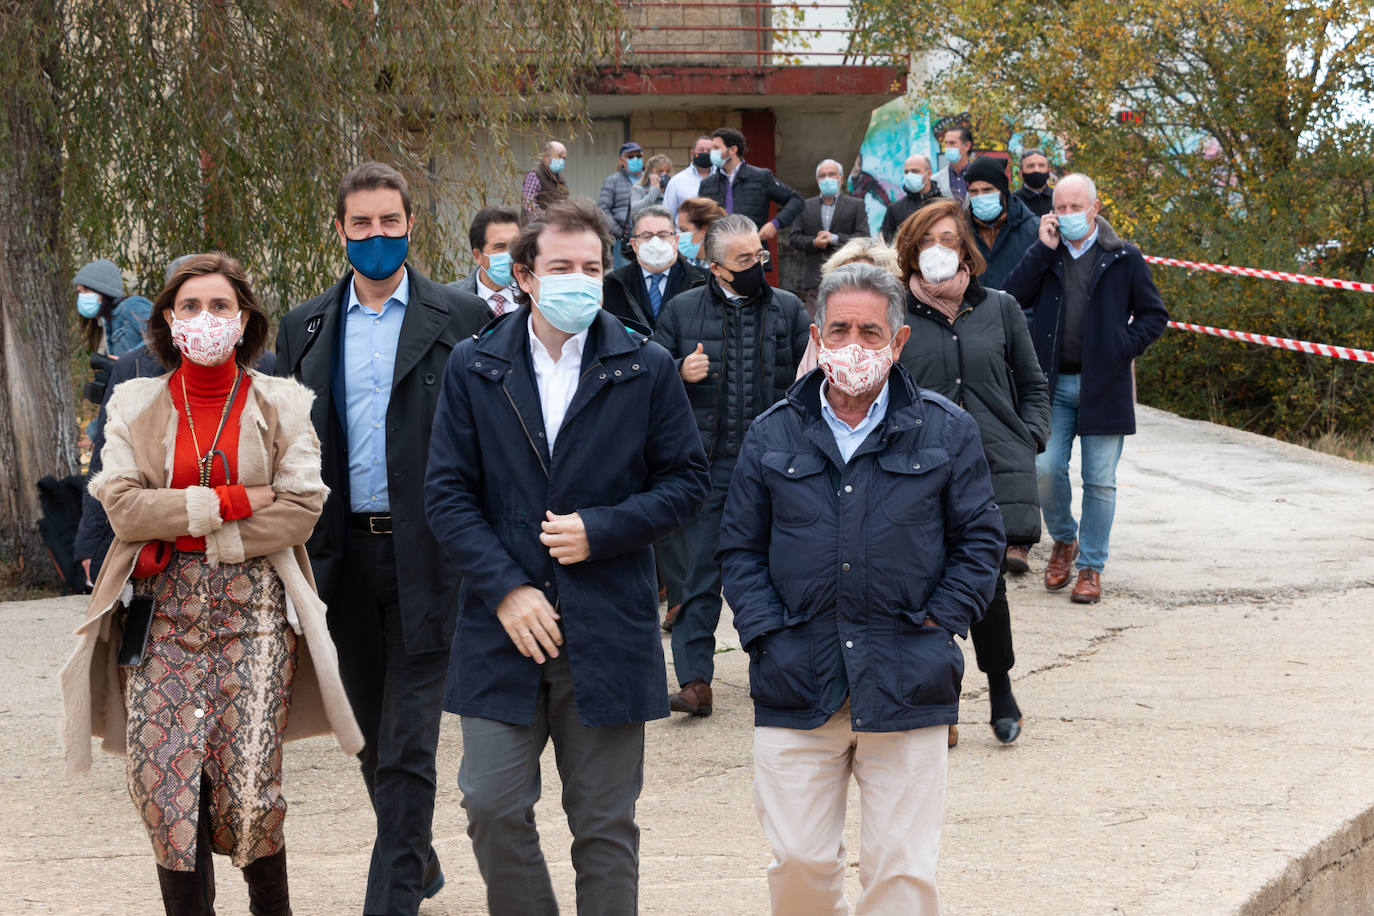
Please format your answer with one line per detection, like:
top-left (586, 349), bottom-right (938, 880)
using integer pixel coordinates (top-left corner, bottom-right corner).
top-left (60, 371), bottom-right (363, 773)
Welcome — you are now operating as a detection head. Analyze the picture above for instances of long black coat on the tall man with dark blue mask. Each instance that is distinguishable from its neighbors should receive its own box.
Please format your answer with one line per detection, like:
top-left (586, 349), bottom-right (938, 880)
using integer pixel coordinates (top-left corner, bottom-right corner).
top-left (276, 265), bottom-right (491, 654)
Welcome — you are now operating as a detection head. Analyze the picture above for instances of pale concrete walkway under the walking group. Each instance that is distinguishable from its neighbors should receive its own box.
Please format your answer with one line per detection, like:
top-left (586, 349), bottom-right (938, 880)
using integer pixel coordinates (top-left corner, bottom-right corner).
top-left (0, 408), bottom-right (1374, 916)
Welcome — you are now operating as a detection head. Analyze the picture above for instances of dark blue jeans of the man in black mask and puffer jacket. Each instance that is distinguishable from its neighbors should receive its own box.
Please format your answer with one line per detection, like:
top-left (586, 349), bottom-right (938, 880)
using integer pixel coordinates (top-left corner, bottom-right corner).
top-left (673, 455), bottom-right (735, 687)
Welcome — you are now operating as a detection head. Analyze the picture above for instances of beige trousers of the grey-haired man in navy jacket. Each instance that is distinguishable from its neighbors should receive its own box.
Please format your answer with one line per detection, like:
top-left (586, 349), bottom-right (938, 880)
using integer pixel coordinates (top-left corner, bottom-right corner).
top-left (754, 702), bottom-right (949, 916)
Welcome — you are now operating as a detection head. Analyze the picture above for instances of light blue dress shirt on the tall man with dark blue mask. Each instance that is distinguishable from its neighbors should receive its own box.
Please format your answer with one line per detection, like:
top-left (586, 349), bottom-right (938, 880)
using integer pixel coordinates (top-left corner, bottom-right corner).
top-left (344, 269), bottom-right (411, 515)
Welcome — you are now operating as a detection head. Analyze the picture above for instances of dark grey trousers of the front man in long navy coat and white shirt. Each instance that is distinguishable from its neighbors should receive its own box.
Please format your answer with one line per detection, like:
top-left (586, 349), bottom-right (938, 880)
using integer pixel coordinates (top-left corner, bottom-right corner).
top-left (458, 650), bottom-right (644, 916)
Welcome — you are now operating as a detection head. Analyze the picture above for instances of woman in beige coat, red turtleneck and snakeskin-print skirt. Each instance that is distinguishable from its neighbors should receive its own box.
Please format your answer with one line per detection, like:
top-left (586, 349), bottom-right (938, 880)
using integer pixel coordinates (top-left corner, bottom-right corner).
top-left (62, 254), bottom-right (363, 915)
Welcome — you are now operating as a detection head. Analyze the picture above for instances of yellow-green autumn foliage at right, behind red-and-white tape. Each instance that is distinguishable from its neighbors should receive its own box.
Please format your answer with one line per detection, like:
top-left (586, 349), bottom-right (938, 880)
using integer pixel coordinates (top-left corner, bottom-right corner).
top-left (853, 0), bottom-right (1374, 437)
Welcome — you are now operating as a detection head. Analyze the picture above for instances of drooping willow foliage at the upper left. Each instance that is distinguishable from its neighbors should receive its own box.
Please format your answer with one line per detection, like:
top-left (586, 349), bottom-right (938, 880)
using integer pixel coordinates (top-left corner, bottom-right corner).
top-left (65, 0), bottom-right (620, 306)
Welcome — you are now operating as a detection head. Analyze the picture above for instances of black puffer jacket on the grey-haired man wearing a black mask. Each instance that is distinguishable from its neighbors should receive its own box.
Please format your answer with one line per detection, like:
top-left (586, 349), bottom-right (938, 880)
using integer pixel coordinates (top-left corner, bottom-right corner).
top-left (654, 277), bottom-right (811, 459)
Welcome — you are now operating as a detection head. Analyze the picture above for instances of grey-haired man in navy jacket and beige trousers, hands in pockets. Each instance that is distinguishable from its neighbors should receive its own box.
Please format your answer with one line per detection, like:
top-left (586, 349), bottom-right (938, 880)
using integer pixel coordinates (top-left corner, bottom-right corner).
top-left (720, 264), bottom-right (1004, 916)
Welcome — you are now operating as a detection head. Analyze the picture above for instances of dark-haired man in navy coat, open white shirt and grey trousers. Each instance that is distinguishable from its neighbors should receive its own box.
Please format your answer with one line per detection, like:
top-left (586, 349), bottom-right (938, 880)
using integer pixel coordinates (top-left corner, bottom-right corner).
top-left (425, 201), bottom-right (706, 915)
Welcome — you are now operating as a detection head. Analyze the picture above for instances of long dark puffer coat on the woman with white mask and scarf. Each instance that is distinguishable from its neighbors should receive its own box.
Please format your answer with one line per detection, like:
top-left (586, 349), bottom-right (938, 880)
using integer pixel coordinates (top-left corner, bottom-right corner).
top-left (901, 290), bottom-right (1050, 544)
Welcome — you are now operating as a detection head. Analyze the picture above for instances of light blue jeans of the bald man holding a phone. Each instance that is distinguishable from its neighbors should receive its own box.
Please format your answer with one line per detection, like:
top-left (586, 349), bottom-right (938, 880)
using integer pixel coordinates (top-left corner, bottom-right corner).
top-left (1035, 375), bottom-right (1125, 573)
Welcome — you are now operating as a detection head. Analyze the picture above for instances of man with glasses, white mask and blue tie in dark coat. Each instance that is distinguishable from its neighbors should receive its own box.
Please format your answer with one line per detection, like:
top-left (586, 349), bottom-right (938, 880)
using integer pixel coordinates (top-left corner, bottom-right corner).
top-left (602, 205), bottom-right (706, 334)
